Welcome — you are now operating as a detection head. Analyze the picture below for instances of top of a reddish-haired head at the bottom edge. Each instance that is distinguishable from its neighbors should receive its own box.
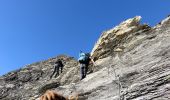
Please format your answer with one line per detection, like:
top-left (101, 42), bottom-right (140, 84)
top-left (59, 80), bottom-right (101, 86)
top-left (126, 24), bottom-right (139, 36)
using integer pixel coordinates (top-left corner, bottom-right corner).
top-left (40, 91), bottom-right (67, 100)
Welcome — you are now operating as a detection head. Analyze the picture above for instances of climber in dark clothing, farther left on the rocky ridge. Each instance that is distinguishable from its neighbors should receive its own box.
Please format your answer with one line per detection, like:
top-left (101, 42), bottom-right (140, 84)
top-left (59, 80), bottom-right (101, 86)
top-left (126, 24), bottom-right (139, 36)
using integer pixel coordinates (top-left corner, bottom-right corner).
top-left (50, 59), bottom-right (64, 78)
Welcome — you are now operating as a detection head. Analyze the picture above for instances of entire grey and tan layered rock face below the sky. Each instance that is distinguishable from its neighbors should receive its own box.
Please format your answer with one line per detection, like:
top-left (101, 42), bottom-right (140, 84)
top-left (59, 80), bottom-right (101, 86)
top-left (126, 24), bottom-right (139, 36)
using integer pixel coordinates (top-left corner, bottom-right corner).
top-left (0, 16), bottom-right (170, 100)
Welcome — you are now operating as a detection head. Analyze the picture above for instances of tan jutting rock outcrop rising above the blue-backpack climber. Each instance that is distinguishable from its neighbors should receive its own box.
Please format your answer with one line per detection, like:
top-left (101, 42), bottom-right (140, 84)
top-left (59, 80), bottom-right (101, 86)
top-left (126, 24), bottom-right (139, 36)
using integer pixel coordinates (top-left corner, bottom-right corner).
top-left (91, 16), bottom-right (149, 60)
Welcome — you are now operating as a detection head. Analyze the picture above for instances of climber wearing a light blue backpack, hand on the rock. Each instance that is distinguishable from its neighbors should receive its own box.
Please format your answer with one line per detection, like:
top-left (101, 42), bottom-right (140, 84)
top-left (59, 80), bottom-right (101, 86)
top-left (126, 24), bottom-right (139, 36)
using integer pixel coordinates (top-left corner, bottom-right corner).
top-left (78, 51), bottom-right (95, 80)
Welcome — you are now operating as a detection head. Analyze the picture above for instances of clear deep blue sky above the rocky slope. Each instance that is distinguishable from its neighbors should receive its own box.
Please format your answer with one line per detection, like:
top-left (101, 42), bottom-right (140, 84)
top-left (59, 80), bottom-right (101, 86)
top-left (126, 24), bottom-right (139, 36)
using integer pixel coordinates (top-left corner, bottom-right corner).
top-left (0, 0), bottom-right (170, 75)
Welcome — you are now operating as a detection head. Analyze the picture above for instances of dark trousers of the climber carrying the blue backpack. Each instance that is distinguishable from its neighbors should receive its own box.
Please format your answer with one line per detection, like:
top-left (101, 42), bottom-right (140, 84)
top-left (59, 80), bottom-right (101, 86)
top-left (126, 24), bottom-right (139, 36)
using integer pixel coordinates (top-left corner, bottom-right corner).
top-left (80, 64), bottom-right (88, 80)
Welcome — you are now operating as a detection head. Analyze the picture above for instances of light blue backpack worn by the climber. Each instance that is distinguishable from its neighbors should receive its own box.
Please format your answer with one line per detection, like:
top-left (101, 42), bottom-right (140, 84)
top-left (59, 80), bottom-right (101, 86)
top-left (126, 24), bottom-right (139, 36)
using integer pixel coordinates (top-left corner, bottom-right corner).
top-left (78, 52), bottom-right (90, 63)
